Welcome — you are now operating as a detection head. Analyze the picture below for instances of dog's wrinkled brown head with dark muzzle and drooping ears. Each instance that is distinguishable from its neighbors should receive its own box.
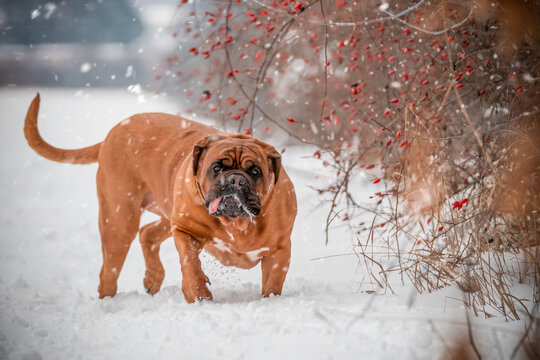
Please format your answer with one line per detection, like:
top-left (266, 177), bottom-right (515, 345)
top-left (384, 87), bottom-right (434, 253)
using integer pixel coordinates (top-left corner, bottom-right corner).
top-left (193, 134), bottom-right (281, 218)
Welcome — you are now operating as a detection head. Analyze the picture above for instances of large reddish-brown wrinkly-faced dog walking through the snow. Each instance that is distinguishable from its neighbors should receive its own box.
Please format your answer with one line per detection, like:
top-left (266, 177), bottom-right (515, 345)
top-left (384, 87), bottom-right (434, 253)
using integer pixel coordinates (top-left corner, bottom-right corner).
top-left (24, 94), bottom-right (296, 303)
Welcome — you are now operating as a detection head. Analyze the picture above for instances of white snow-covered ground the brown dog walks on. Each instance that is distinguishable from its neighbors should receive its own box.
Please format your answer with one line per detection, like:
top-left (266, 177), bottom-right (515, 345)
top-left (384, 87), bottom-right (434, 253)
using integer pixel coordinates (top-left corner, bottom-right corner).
top-left (0, 88), bottom-right (524, 360)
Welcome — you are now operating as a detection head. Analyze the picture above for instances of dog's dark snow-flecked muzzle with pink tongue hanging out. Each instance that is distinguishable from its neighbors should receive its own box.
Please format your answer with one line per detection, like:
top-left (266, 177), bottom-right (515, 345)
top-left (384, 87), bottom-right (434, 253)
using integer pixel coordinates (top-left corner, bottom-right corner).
top-left (205, 171), bottom-right (261, 218)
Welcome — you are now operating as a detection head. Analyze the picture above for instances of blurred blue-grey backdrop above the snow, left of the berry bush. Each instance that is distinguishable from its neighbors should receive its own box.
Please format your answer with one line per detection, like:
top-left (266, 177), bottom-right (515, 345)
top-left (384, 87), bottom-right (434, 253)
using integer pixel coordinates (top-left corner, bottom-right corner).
top-left (0, 0), bottom-right (178, 87)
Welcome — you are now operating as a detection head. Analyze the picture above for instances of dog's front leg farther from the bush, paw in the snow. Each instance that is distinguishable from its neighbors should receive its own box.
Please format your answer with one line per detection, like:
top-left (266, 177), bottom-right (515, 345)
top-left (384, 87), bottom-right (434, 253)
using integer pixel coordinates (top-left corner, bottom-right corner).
top-left (173, 229), bottom-right (212, 303)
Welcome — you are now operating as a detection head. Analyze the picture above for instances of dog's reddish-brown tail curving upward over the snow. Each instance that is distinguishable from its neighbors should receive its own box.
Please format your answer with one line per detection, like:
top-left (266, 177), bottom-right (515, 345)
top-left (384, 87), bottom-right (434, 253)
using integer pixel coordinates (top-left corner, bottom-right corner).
top-left (24, 93), bottom-right (101, 164)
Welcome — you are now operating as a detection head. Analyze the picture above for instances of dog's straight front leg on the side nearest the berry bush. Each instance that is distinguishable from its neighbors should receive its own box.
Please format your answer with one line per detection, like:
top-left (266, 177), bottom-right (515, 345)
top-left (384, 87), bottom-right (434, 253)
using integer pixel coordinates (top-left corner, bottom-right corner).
top-left (261, 246), bottom-right (291, 297)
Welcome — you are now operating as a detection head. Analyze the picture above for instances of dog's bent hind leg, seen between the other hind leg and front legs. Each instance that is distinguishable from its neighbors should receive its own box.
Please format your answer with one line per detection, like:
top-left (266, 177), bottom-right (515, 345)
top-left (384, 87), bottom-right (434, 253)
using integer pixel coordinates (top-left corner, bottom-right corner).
top-left (139, 218), bottom-right (172, 295)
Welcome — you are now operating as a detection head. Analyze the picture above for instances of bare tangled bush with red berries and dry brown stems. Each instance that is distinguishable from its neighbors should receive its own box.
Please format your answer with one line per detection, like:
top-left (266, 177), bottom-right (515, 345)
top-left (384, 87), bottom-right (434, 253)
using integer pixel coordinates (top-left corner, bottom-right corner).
top-left (160, 0), bottom-right (540, 319)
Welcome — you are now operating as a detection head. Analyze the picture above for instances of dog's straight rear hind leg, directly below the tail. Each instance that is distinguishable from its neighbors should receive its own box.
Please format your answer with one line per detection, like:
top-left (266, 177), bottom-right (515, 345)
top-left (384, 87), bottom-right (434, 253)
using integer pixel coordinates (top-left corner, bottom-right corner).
top-left (97, 170), bottom-right (143, 299)
